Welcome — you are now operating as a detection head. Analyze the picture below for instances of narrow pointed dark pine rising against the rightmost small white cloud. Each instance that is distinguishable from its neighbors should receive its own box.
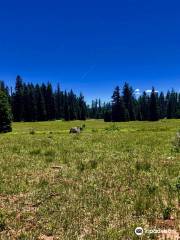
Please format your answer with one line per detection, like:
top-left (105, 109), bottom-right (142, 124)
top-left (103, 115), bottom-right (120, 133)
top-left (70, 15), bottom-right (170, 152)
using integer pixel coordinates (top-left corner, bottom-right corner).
top-left (149, 87), bottom-right (159, 121)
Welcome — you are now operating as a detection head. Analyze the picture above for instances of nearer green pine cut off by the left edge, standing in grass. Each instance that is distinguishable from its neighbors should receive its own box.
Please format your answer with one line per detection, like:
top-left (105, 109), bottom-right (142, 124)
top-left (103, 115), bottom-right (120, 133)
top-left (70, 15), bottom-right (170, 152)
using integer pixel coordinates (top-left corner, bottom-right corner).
top-left (0, 90), bottom-right (12, 133)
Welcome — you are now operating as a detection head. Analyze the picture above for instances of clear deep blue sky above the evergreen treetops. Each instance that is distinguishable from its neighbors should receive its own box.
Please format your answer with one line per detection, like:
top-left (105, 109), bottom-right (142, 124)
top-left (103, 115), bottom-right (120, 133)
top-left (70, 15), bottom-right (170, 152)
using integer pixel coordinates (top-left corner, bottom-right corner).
top-left (0, 0), bottom-right (180, 101)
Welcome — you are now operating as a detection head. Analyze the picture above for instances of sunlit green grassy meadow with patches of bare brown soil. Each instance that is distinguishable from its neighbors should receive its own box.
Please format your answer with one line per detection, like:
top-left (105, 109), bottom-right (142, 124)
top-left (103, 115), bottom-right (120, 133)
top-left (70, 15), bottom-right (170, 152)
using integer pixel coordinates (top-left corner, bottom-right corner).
top-left (0, 120), bottom-right (180, 240)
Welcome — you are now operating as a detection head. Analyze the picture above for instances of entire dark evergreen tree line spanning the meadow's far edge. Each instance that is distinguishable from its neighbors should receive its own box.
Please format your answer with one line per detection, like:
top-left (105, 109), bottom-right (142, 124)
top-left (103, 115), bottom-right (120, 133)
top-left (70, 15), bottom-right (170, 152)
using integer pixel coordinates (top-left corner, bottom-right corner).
top-left (0, 76), bottom-right (180, 132)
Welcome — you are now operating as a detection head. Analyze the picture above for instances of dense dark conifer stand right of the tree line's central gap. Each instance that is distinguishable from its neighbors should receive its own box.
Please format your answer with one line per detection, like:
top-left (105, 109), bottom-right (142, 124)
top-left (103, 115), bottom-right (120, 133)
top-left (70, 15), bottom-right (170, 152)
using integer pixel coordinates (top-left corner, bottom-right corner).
top-left (104, 83), bottom-right (180, 122)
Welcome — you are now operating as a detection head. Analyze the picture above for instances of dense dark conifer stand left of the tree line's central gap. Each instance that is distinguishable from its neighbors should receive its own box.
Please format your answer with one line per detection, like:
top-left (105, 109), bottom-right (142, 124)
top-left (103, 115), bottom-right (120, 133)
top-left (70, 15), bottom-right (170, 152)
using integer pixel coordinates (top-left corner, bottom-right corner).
top-left (4, 76), bottom-right (87, 122)
